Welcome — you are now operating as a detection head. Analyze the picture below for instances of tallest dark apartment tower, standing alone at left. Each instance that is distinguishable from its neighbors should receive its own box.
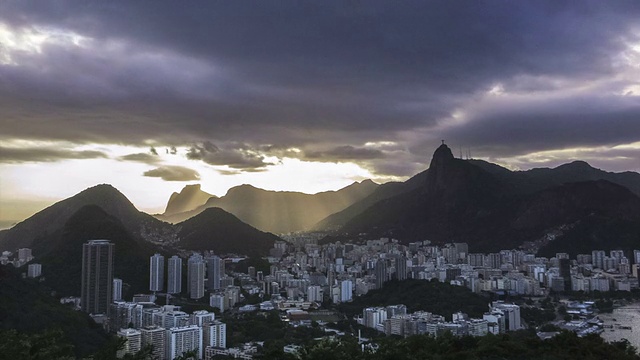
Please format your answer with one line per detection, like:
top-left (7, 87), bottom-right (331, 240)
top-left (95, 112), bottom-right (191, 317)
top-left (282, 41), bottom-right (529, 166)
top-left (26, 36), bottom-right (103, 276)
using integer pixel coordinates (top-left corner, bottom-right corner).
top-left (80, 240), bottom-right (114, 315)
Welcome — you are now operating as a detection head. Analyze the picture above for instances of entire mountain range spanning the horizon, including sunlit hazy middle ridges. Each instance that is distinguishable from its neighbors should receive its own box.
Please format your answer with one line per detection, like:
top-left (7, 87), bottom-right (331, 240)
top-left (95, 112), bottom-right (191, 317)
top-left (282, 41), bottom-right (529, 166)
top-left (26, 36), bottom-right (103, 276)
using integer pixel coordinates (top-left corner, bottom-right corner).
top-left (0, 144), bottom-right (640, 262)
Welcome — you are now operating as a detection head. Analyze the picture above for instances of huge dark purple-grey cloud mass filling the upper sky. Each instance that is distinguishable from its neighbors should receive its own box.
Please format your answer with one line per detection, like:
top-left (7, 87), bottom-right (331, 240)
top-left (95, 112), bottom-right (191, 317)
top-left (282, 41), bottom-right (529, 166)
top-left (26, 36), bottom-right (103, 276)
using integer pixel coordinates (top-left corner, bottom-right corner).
top-left (0, 1), bottom-right (640, 174)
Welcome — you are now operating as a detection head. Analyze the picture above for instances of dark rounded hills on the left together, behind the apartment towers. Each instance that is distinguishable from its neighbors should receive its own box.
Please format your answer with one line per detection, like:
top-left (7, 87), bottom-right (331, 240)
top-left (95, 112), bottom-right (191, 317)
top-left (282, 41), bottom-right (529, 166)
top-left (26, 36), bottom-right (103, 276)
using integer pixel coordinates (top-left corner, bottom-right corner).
top-left (0, 185), bottom-right (279, 296)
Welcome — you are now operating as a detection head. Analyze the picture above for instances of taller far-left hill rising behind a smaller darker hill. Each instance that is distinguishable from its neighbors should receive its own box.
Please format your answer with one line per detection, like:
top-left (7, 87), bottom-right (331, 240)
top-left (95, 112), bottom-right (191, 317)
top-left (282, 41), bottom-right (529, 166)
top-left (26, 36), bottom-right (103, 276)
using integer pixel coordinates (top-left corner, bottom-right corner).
top-left (0, 184), bottom-right (171, 251)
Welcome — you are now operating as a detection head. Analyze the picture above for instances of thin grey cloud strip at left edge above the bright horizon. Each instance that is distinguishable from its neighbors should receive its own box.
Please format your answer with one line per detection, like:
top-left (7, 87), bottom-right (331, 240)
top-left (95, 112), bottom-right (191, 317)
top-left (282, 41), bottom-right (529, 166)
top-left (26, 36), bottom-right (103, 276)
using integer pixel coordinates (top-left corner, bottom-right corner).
top-left (0, 146), bottom-right (107, 163)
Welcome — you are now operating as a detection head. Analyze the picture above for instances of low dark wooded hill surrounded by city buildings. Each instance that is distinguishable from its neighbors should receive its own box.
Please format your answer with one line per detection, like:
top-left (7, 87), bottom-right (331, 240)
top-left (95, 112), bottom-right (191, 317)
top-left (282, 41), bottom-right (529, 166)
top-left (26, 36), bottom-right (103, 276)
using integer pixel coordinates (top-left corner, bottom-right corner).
top-left (339, 279), bottom-right (489, 320)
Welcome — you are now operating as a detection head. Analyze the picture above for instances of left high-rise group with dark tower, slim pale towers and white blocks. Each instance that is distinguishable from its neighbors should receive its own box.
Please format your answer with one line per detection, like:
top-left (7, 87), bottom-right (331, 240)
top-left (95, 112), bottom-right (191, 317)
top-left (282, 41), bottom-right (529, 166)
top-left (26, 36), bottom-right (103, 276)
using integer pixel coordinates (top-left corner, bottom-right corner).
top-left (77, 240), bottom-right (226, 359)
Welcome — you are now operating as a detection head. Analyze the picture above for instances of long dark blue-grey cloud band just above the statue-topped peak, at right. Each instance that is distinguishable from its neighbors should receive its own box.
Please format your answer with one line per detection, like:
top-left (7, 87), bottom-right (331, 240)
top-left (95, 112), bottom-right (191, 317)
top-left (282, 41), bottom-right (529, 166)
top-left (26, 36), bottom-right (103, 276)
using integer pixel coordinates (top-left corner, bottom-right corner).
top-left (443, 96), bottom-right (640, 157)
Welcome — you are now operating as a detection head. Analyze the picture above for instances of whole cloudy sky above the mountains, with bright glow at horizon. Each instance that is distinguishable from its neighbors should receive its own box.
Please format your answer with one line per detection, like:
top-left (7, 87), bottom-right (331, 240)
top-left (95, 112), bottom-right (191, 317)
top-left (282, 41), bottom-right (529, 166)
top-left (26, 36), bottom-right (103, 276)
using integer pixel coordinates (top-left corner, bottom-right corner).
top-left (0, 0), bottom-right (640, 225)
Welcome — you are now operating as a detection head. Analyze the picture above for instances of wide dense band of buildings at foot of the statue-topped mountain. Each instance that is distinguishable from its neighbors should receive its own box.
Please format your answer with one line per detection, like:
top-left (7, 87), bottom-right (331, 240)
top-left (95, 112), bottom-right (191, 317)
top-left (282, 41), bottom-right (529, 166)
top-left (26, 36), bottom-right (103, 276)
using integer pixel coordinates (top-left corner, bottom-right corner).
top-left (257, 236), bottom-right (640, 303)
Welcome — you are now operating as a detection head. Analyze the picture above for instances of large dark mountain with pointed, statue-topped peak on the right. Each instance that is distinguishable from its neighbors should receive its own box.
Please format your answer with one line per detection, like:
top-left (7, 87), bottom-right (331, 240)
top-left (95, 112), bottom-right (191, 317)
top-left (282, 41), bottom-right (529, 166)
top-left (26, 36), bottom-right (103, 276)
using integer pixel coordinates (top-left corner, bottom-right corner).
top-left (325, 145), bottom-right (640, 252)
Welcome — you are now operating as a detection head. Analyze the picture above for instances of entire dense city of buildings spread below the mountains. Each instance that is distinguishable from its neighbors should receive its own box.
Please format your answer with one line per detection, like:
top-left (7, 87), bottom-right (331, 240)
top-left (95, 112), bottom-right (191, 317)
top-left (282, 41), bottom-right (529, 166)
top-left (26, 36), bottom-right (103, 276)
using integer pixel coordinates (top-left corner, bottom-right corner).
top-left (0, 233), bottom-right (640, 359)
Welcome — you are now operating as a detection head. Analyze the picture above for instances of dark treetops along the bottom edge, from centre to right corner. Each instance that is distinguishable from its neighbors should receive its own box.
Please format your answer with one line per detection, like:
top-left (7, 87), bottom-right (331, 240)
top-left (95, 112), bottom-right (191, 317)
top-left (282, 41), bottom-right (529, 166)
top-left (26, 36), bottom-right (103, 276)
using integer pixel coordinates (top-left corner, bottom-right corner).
top-left (278, 331), bottom-right (640, 360)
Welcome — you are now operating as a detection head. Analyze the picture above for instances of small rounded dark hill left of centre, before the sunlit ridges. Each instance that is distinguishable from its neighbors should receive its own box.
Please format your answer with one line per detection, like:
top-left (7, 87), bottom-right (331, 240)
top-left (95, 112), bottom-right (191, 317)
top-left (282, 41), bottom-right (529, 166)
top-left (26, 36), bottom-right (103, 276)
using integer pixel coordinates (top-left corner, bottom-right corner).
top-left (176, 208), bottom-right (280, 255)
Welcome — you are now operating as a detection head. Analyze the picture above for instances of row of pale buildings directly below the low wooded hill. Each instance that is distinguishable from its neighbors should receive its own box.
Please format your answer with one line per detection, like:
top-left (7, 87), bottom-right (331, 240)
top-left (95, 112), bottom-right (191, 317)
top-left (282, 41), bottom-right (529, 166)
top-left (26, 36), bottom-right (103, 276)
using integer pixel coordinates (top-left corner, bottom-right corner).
top-left (357, 302), bottom-right (521, 337)
